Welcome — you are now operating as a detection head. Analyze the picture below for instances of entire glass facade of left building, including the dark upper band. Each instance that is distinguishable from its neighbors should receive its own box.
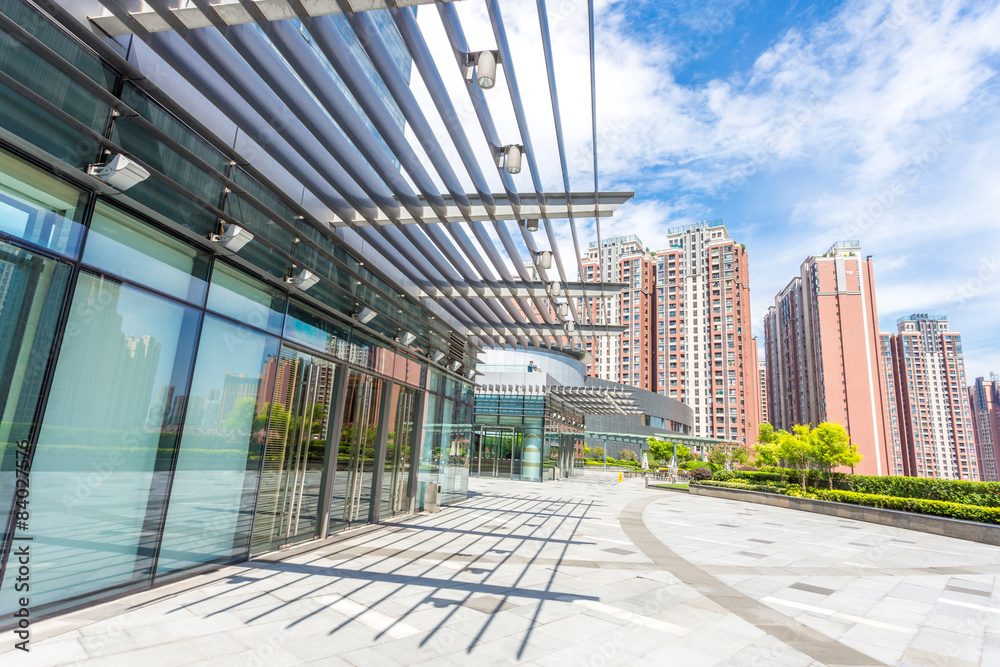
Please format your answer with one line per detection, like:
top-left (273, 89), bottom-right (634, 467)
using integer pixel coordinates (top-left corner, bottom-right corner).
top-left (0, 0), bottom-right (474, 628)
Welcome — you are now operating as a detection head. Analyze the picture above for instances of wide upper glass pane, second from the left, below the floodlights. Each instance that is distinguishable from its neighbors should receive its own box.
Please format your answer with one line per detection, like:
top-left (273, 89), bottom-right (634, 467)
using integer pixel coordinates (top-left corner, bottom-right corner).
top-left (83, 202), bottom-right (208, 305)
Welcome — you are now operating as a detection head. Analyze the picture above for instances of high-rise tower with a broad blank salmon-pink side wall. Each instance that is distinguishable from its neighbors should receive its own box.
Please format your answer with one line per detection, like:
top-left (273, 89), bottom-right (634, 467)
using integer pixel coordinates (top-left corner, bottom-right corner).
top-left (764, 241), bottom-right (895, 475)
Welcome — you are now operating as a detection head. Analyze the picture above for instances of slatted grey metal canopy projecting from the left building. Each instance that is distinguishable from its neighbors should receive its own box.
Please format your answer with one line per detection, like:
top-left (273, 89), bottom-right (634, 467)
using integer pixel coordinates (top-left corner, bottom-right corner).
top-left (84, 0), bottom-right (632, 349)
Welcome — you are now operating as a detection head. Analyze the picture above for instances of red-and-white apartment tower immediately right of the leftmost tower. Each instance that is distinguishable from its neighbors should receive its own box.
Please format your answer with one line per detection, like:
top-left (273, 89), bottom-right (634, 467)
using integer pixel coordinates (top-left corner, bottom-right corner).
top-left (656, 220), bottom-right (760, 444)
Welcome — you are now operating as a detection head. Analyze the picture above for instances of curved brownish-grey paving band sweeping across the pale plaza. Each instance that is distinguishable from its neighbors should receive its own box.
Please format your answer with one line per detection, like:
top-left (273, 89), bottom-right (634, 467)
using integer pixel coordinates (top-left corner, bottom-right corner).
top-left (618, 496), bottom-right (886, 666)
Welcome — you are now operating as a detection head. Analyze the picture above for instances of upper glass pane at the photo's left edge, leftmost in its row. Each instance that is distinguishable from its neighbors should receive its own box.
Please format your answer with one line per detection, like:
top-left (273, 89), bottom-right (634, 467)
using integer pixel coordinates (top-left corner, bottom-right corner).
top-left (0, 152), bottom-right (86, 256)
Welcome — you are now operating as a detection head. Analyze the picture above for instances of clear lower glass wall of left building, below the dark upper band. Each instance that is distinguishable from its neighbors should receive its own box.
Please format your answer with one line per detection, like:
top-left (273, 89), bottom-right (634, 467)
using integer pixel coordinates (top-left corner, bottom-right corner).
top-left (0, 140), bottom-right (472, 615)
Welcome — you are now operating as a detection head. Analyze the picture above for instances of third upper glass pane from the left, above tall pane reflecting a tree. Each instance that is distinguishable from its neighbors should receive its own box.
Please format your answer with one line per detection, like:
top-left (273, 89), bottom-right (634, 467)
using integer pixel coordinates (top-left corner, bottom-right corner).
top-left (208, 262), bottom-right (285, 334)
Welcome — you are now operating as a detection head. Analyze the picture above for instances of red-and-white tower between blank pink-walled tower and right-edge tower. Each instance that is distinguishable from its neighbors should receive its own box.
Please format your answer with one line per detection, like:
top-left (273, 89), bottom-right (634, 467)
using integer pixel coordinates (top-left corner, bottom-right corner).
top-left (882, 313), bottom-right (981, 480)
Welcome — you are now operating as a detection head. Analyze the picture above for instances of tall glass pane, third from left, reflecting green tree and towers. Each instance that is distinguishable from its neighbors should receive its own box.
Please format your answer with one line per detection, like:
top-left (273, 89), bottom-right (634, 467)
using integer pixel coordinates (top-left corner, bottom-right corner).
top-left (156, 316), bottom-right (278, 576)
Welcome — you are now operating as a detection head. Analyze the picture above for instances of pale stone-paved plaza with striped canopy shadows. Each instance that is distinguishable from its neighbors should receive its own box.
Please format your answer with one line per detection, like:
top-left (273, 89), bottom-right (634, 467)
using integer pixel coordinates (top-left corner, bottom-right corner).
top-left (0, 474), bottom-right (1000, 667)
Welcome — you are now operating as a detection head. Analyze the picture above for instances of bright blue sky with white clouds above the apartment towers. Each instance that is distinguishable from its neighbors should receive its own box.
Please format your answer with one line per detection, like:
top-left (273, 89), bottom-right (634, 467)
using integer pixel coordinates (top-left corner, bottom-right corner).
top-left (426, 0), bottom-right (1000, 381)
